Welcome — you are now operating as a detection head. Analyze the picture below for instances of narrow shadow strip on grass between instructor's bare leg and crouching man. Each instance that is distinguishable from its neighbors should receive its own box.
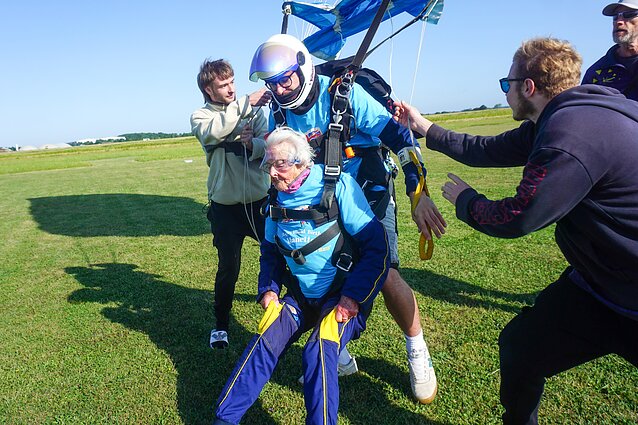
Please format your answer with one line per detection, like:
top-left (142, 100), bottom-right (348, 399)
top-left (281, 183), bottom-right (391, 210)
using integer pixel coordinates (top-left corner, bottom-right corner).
top-left (401, 268), bottom-right (538, 313)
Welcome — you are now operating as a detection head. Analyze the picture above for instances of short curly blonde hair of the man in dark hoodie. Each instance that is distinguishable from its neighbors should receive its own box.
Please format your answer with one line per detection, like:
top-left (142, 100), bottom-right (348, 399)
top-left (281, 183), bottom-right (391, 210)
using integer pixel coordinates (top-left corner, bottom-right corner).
top-left (513, 37), bottom-right (583, 99)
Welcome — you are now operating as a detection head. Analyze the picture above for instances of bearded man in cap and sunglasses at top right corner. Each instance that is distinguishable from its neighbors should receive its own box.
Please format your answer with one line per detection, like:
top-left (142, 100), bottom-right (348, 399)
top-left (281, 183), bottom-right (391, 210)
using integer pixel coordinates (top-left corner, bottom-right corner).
top-left (583, 0), bottom-right (638, 100)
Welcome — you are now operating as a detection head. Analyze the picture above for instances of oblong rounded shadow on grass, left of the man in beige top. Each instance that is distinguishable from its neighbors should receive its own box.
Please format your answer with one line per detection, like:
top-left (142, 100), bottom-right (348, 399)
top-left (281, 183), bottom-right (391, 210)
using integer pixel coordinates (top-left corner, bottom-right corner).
top-left (29, 193), bottom-right (210, 237)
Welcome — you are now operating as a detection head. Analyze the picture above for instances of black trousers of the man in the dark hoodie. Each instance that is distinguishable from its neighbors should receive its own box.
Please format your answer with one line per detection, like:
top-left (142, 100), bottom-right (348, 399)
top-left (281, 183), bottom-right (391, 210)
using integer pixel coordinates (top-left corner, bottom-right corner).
top-left (499, 269), bottom-right (638, 424)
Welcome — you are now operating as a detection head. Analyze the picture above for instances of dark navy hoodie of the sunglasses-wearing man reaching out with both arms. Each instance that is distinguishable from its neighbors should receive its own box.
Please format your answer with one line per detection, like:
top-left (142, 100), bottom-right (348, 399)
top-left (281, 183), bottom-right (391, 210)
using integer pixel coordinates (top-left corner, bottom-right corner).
top-left (426, 84), bottom-right (638, 320)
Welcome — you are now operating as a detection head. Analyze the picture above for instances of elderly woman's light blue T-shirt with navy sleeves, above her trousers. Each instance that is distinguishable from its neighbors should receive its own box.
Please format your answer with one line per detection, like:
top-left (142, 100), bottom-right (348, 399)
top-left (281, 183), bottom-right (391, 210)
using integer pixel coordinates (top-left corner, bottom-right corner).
top-left (258, 165), bottom-right (389, 306)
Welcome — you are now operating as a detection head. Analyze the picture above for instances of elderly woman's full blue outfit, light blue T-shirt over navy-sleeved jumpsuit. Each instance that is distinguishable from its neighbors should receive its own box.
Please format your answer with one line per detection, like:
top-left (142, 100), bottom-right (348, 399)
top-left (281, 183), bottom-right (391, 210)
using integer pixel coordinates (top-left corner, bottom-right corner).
top-left (215, 165), bottom-right (389, 424)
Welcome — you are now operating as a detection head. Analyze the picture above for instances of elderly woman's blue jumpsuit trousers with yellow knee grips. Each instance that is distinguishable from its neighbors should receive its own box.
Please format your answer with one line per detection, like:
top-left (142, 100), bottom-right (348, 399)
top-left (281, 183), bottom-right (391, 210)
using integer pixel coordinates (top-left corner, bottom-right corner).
top-left (214, 294), bottom-right (371, 425)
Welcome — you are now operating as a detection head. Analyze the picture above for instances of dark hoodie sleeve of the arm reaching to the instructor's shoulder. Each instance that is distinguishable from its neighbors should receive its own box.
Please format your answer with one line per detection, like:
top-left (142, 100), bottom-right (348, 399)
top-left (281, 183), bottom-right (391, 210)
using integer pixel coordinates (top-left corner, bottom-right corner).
top-left (426, 121), bottom-right (535, 167)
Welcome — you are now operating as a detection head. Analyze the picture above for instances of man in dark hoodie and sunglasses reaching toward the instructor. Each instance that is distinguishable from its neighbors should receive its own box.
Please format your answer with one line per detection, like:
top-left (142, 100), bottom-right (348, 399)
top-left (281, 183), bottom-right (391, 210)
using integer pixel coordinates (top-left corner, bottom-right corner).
top-left (395, 38), bottom-right (638, 424)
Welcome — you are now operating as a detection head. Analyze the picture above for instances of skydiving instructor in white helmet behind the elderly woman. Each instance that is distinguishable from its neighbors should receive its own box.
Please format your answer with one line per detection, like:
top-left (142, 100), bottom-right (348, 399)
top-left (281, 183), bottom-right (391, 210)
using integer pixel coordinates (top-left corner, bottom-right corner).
top-left (250, 34), bottom-right (446, 404)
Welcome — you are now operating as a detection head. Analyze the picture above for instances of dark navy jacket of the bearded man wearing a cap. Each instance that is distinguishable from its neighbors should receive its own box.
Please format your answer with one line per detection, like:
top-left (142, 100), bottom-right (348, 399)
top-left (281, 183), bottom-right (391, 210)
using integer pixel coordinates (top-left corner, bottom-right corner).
top-left (583, 44), bottom-right (638, 100)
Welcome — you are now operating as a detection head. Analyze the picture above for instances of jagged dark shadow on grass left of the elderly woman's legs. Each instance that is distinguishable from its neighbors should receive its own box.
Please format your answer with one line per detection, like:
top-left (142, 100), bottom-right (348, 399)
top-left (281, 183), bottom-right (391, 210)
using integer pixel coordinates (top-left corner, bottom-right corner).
top-left (65, 263), bottom-right (274, 424)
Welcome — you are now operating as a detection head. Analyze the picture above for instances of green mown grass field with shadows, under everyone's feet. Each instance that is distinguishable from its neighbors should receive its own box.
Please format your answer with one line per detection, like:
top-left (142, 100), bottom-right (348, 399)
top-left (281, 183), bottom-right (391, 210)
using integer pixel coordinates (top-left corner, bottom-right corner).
top-left (0, 110), bottom-right (638, 425)
